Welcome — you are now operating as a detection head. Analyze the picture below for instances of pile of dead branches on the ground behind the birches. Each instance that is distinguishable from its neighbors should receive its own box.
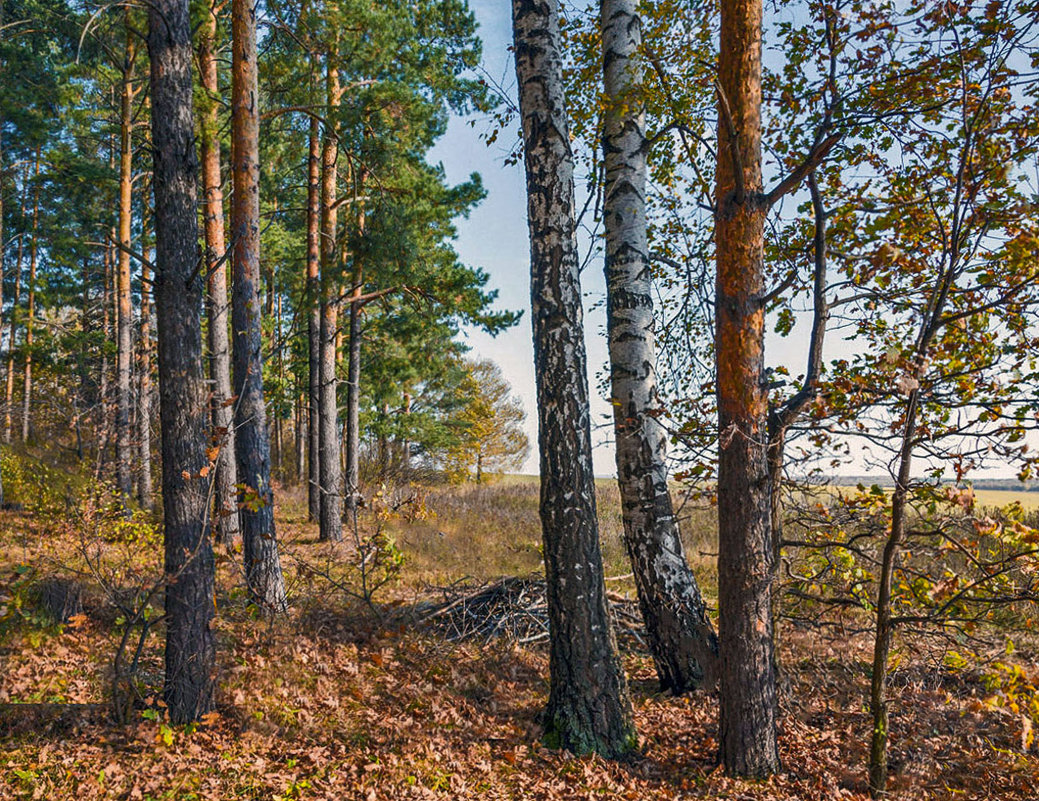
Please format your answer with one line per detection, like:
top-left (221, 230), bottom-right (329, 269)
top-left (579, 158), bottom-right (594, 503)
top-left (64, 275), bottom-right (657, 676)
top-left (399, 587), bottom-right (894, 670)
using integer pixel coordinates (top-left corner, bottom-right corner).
top-left (417, 576), bottom-right (645, 648)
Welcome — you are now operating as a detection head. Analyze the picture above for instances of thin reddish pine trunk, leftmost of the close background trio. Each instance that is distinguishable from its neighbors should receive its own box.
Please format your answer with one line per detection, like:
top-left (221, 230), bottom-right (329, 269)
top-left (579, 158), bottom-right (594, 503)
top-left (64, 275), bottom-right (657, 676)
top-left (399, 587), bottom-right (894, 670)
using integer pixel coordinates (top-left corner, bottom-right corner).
top-left (307, 117), bottom-right (322, 522)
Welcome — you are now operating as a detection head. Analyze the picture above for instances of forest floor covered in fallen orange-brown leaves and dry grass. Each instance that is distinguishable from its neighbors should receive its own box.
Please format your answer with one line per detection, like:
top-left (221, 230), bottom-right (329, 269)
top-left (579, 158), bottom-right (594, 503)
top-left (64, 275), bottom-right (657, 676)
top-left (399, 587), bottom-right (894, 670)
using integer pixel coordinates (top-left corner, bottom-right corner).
top-left (0, 481), bottom-right (1039, 801)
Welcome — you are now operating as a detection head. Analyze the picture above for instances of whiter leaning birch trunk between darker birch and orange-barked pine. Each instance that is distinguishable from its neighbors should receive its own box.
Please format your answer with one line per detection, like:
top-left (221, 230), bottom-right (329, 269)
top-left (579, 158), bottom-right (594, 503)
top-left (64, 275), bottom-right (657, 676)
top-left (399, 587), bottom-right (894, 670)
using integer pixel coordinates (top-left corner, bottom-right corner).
top-left (600, 0), bottom-right (718, 693)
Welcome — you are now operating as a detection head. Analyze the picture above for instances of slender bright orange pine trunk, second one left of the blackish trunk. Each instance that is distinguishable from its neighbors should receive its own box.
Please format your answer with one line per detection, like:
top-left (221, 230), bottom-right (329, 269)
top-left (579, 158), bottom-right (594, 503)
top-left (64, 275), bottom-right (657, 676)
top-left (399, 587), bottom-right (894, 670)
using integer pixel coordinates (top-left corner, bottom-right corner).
top-left (115, 18), bottom-right (136, 501)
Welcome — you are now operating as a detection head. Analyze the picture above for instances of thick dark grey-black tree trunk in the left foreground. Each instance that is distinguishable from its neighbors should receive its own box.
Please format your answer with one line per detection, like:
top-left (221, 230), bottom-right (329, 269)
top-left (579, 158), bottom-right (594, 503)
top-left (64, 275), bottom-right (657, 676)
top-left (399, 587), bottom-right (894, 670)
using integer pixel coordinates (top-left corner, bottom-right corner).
top-left (148, 0), bottom-right (216, 723)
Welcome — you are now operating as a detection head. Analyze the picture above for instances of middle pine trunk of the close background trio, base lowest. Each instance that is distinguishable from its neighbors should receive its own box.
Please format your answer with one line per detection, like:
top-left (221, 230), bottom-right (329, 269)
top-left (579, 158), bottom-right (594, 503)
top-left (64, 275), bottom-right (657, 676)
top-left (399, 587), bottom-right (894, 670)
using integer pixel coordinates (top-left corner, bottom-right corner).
top-left (318, 51), bottom-right (343, 542)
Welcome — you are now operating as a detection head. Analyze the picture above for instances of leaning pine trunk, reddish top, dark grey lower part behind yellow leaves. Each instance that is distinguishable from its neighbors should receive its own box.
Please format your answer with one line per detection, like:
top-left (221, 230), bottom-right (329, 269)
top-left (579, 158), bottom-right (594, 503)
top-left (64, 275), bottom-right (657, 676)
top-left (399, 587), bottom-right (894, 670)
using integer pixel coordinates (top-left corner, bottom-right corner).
top-left (231, 0), bottom-right (287, 612)
